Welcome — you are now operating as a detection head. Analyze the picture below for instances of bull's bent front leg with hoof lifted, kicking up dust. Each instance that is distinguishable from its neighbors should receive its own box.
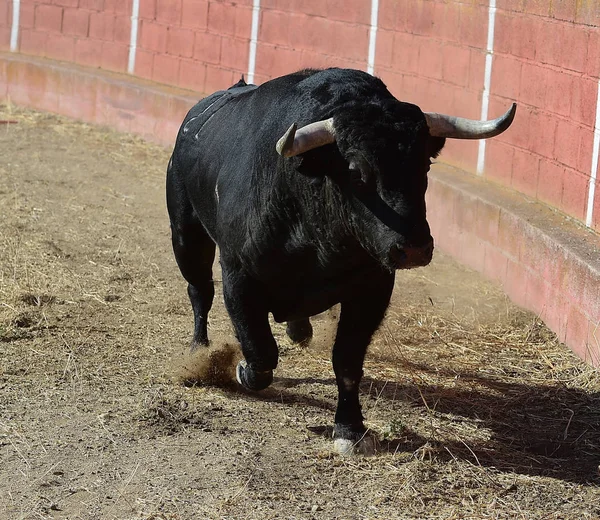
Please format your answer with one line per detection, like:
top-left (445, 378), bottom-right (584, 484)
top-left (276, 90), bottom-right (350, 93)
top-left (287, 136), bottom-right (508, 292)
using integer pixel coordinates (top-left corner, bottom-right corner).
top-left (221, 261), bottom-right (279, 391)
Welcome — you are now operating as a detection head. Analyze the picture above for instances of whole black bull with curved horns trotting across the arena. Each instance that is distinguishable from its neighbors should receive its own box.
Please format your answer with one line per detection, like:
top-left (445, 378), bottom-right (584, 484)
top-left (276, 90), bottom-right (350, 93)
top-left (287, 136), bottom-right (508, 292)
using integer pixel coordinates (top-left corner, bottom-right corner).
top-left (167, 69), bottom-right (515, 452)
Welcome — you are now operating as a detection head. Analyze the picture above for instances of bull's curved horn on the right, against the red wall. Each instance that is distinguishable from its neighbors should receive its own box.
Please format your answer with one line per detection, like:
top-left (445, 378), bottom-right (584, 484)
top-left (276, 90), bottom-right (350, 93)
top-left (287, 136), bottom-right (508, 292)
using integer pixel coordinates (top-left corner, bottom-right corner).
top-left (425, 103), bottom-right (517, 139)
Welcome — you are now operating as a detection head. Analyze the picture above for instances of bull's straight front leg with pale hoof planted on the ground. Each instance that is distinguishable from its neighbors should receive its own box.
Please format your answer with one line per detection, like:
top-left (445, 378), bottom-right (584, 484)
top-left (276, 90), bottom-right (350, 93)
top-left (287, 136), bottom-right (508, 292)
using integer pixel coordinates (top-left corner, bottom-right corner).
top-left (332, 273), bottom-right (394, 455)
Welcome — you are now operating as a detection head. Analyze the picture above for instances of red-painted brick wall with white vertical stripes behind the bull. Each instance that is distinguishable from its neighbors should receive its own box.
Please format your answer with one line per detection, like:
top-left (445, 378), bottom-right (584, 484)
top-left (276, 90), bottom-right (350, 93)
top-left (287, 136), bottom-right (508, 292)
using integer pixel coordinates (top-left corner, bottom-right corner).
top-left (0, 0), bottom-right (600, 230)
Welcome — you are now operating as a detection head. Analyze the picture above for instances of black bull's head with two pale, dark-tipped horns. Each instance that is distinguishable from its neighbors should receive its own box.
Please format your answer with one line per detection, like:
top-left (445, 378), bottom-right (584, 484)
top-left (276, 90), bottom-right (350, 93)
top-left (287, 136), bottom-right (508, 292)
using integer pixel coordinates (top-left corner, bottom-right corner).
top-left (276, 100), bottom-right (516, 269)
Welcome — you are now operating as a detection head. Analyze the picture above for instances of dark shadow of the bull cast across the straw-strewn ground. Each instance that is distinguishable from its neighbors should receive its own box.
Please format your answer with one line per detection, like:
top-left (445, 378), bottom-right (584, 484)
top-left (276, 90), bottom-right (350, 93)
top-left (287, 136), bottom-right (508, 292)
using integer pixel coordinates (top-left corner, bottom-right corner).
top-left (232, 362), bottom-right (600, 484)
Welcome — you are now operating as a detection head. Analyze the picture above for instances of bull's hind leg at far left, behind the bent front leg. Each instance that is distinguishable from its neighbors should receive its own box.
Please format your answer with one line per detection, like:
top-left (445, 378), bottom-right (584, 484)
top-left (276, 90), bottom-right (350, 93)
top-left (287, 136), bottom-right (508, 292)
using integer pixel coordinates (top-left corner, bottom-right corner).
top-left (167, 172), bottom-right (215, 350)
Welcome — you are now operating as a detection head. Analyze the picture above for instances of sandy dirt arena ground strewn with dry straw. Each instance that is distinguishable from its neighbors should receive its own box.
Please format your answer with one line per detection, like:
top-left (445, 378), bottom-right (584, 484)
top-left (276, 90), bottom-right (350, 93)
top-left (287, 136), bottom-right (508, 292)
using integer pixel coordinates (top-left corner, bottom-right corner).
top-left (0, 106), bottom-right (600, 520)
